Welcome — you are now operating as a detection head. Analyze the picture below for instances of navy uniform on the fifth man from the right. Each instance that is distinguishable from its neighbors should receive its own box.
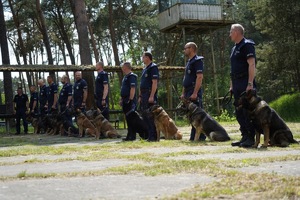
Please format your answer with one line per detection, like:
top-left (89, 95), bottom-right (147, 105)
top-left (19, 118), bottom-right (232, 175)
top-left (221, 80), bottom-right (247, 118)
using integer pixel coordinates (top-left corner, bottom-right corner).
top-left (95, 71), bottom-right (109, 120)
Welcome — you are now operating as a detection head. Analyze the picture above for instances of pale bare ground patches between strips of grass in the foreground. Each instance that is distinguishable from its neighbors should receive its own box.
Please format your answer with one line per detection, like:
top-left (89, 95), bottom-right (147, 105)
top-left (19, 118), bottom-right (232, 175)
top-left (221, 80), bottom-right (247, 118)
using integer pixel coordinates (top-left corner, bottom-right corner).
top-left (0, 125), bottom-right (300, 200)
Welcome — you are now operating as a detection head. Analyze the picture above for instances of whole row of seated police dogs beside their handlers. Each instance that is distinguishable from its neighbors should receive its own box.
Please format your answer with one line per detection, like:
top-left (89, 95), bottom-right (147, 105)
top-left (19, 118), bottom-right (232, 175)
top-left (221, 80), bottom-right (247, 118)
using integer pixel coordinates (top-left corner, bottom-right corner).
top-left (28, 90), bottom-right (298, 148)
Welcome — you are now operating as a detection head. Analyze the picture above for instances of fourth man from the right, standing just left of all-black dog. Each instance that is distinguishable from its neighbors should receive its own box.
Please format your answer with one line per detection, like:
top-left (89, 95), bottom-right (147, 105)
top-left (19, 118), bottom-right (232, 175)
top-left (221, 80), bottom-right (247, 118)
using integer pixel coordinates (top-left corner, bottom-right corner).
top-left (120, 62), bottom-right (137, 141)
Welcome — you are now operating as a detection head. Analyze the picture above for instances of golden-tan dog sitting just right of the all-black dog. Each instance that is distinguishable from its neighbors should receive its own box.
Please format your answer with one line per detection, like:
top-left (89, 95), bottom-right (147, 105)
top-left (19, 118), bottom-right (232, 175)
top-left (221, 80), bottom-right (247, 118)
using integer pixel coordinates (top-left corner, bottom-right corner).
top-left (150, 105), bottom-right (182, 141)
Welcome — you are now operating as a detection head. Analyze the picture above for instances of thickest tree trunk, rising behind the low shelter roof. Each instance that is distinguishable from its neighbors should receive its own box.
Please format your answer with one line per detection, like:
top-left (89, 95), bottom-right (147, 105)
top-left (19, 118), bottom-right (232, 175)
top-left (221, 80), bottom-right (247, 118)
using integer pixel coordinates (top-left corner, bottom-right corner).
top-left (70, 0), bottom-right (95, 109)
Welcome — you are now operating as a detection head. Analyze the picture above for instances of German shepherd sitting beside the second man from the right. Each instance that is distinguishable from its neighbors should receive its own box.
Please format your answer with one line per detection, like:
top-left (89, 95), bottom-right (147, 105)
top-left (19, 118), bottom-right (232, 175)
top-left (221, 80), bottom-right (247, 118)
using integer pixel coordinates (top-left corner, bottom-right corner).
top-left (176, 100), bottom-right (230, 142)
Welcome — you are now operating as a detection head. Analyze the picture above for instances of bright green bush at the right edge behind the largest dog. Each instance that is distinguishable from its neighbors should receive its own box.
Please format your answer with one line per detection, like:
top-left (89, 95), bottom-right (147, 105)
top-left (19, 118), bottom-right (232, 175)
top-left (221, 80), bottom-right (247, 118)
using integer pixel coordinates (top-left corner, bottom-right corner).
top-left (269, 93), bottom-right (300, 122)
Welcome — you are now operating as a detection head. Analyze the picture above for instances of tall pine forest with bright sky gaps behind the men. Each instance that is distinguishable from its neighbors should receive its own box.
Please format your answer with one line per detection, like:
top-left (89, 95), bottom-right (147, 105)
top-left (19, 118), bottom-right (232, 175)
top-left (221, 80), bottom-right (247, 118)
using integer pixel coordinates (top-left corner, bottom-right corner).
top-left (0, 0), bottom-right (300, 120)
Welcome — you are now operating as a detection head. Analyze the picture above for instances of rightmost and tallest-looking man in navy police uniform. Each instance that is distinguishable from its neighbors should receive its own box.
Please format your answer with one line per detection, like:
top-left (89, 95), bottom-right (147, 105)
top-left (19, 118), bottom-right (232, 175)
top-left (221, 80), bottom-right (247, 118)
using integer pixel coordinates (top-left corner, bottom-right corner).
top-left (230, 24), bottom-right (256, 148)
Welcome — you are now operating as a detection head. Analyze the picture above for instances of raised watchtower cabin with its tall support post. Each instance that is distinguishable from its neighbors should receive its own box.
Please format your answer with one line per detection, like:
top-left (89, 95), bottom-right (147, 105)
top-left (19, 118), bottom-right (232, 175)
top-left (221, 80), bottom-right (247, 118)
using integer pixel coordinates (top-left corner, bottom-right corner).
top-left (158, 0), bottom-right (234, 114)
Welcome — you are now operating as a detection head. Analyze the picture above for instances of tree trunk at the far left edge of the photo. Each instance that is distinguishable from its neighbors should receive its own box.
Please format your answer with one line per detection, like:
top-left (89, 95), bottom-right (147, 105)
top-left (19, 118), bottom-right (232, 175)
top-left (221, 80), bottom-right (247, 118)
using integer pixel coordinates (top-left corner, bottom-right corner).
top-left (0, 0), bottom-right (13, 117)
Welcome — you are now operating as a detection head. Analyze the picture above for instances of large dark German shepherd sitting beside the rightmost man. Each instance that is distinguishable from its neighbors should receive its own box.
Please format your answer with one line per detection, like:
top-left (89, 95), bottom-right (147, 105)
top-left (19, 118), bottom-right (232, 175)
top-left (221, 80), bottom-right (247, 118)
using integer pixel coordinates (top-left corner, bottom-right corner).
top-left (238, 90), bottom-right (298, 148)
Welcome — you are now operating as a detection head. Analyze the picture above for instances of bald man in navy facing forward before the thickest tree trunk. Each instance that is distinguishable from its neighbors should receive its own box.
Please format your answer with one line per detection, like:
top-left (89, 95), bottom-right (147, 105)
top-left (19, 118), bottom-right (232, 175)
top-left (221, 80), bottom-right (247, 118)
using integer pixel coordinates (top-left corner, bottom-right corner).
top-left (73, 71), bottom-right (87, 112)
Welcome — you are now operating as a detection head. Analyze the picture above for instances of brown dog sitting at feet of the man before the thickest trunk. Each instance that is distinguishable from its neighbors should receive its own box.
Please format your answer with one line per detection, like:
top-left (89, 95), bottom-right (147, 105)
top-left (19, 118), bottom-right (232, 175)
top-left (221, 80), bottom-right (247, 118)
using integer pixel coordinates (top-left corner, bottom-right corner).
top-left (75, 109), bottom-right (100, 139)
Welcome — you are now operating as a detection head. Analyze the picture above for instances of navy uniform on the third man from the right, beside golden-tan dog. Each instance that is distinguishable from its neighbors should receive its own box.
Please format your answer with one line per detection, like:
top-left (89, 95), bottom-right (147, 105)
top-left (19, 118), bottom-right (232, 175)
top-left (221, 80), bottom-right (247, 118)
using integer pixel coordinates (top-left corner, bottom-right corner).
top-left (140, 63), bottom-right (159, 141)
